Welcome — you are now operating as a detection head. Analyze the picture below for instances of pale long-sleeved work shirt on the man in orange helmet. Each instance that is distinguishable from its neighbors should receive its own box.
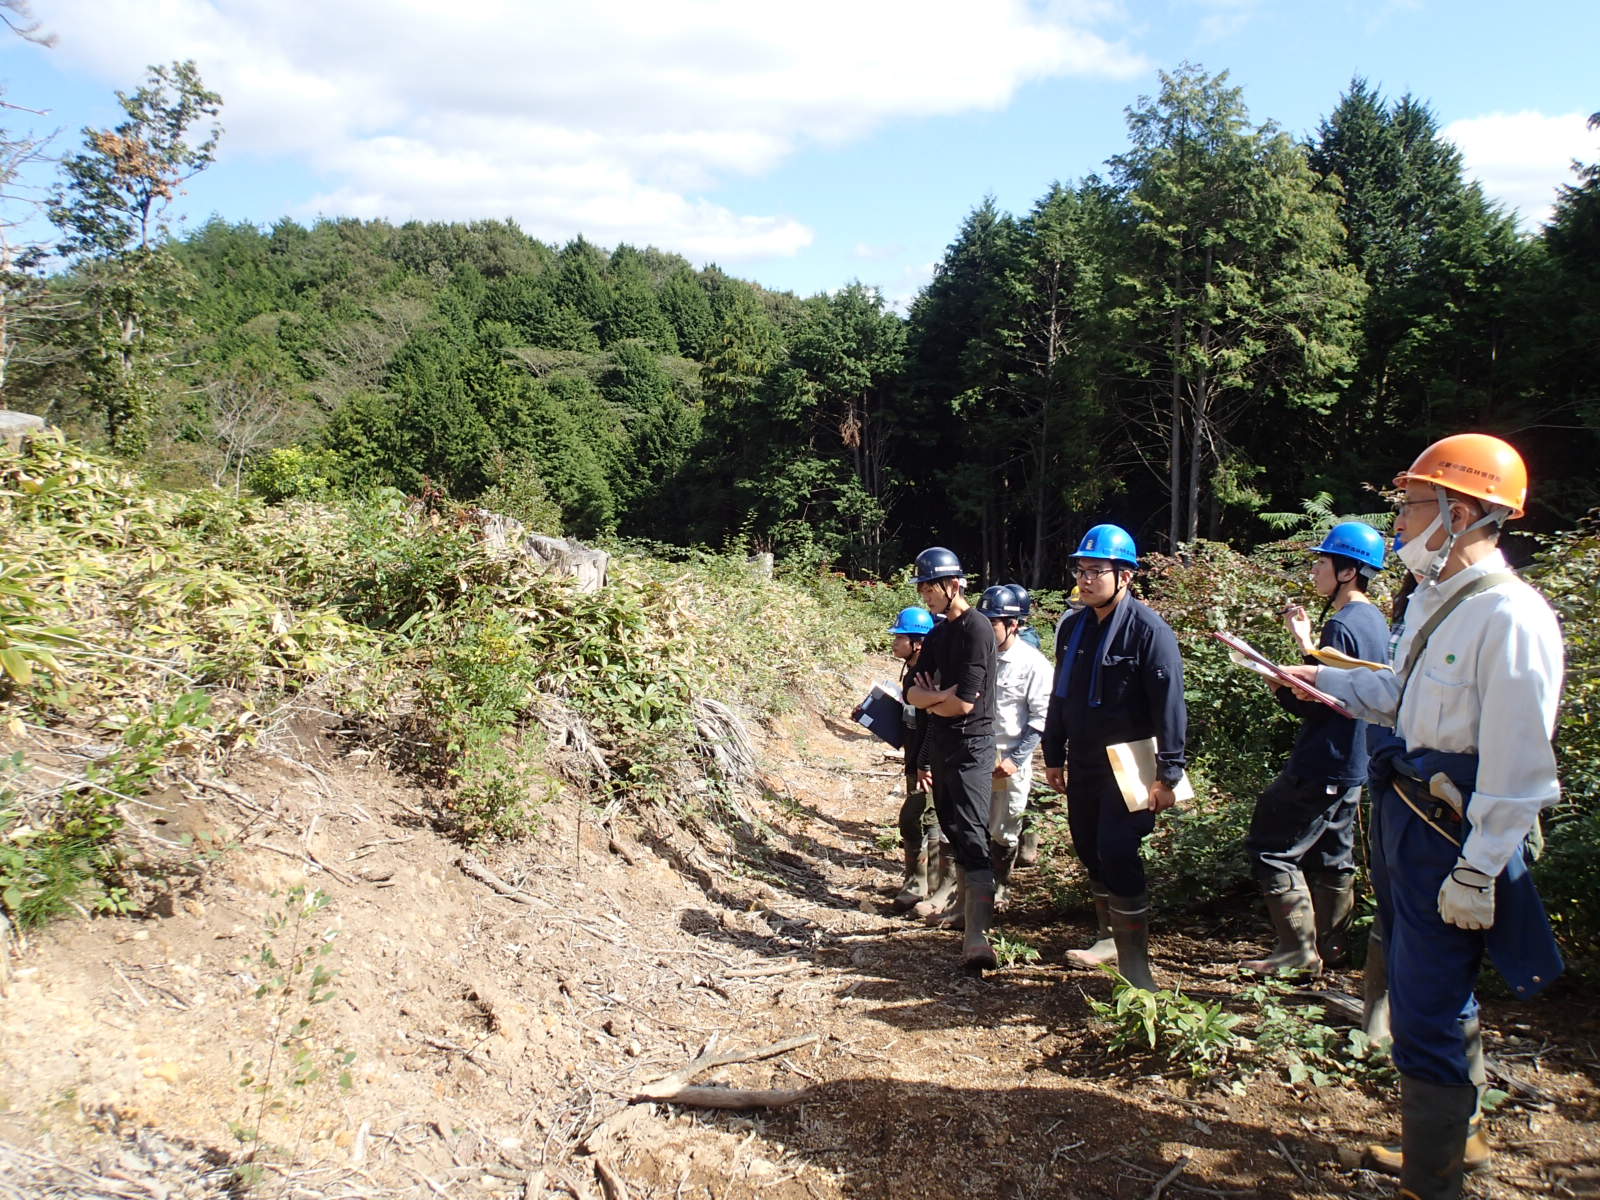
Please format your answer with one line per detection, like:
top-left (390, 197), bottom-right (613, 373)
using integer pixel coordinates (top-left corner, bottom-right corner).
top-left (1317, 550), bottom-right (1563, 875)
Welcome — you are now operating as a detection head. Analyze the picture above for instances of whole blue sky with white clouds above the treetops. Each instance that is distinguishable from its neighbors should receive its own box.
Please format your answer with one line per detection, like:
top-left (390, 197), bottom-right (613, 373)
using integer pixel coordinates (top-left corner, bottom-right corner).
top-left (0, 0), bottom-right (1600, 304)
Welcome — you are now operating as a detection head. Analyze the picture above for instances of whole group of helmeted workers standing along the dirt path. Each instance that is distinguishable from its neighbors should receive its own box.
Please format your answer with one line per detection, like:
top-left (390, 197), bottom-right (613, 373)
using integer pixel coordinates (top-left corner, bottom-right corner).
top-left (864, 434), bottom-right (1563, 1200)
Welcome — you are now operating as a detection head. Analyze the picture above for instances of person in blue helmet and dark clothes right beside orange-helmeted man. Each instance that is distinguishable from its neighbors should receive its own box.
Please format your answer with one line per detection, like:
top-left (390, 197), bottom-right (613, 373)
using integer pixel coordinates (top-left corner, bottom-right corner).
top-left (1240, 522), bottom-right (1389, 974)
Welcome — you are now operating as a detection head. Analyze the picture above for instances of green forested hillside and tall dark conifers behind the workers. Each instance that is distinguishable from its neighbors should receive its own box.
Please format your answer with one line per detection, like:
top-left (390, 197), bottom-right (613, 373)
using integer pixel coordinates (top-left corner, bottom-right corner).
top-left (3, 64), bottom-right (1600, 586)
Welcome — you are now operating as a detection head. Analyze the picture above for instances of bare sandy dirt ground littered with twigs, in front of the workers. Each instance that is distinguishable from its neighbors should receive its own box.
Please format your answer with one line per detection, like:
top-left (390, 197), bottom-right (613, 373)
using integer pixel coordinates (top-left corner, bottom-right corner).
top-left (0, 672), bottom-right (1600, 1200)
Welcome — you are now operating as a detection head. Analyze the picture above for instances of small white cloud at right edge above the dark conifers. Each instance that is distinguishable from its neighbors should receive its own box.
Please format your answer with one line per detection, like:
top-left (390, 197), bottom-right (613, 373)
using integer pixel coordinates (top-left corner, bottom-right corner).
top-left (1443, 112), bottom-right (1600, 229)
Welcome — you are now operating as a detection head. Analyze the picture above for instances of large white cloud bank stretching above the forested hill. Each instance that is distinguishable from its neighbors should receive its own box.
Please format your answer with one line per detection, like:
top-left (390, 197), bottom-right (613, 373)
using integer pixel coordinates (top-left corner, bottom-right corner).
top-left (50, 0), bottom-right (1147, 259)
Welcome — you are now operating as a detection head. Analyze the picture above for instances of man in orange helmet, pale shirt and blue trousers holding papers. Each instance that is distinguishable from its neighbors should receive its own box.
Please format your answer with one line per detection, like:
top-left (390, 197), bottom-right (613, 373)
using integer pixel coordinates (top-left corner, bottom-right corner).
top-left (1288, 434), bottom-right (1562, 1200)
